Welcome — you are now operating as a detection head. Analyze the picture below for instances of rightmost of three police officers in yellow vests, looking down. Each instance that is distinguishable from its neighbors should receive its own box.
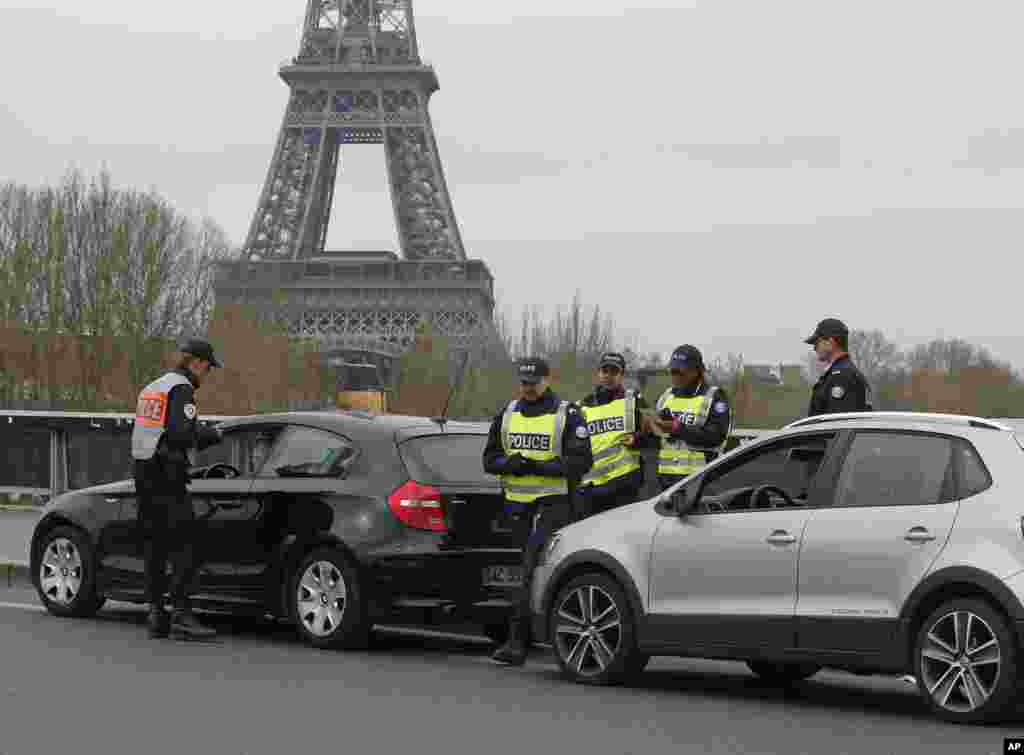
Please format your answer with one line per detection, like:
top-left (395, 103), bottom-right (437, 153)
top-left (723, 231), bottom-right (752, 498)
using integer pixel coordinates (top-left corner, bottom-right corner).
top-left (649, 344), bottom-right (732, 490)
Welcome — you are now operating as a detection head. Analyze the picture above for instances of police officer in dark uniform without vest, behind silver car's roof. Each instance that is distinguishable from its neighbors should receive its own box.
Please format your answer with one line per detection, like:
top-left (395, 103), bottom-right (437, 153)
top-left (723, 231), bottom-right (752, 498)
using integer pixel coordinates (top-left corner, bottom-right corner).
top-left (804, 318), bottom-right (871, 417)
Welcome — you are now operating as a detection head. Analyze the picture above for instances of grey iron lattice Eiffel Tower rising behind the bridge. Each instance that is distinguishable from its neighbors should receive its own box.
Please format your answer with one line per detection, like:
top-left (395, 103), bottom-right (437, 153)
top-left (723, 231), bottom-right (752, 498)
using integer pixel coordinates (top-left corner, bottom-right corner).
top-left (215, 0), bottom-right (498, 379)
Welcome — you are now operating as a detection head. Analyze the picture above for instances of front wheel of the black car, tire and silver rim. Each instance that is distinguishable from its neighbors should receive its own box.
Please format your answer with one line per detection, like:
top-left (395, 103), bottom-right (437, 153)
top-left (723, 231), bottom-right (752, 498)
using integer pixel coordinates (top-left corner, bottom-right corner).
top-left (32, 526), bottom-right (105, 619)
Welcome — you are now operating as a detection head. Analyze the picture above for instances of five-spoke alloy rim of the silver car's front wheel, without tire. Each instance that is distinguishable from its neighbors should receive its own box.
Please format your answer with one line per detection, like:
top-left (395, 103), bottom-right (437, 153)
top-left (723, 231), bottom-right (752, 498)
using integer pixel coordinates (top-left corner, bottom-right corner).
top-left (555, 585), bottom-right (623, 676)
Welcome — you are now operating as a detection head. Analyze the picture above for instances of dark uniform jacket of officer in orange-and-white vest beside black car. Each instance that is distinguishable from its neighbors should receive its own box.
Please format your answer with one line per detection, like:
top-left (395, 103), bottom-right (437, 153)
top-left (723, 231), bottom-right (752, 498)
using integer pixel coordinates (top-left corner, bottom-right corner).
top-left (135, 370), bottom-right (220, 485)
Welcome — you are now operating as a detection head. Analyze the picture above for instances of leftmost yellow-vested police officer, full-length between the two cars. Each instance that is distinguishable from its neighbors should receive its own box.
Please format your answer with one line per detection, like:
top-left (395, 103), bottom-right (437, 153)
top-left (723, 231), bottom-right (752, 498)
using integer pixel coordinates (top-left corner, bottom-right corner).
top-left (483, 358), bottom-right (593, 666)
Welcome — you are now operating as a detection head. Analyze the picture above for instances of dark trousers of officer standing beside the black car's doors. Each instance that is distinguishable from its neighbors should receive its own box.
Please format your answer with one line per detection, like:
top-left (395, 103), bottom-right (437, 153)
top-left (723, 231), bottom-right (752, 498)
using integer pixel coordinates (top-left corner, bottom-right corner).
top-left (135, 455), bottom-right (199, 607)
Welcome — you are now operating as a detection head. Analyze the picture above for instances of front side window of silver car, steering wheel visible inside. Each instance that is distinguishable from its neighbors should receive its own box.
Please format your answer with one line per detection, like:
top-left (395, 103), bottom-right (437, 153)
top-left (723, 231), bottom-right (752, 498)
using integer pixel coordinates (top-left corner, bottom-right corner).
top-left (698, 433), bottom-right (836, 513)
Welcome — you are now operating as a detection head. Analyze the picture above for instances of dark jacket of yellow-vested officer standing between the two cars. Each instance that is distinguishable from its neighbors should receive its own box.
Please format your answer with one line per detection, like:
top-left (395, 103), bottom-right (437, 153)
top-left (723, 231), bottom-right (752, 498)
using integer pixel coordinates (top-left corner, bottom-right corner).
top-left (483, 388), bottom-right (594, 502)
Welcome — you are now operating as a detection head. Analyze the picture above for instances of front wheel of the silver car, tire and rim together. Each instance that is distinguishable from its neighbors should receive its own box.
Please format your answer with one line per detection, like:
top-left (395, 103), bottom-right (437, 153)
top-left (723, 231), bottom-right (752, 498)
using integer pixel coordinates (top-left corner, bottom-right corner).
top-left (548, 573), bottom-right (650, 684)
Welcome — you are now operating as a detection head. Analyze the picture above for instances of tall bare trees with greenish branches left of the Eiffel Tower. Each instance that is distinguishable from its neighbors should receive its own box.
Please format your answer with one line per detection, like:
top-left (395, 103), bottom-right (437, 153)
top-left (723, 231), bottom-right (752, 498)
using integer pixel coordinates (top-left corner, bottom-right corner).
top-left (0, 172), bottom-right (229, 401)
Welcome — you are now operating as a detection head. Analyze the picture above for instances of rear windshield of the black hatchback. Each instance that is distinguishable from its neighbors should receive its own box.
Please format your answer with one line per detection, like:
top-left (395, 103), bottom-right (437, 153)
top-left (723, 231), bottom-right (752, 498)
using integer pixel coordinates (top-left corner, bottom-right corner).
top-left (398, 435), bottom-right (498, 486)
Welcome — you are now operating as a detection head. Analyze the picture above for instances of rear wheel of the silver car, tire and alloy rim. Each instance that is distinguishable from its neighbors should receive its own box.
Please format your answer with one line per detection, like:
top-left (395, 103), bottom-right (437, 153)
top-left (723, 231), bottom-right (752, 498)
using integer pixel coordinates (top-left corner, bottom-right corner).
top-left (913, 598), bottom-right (1020, 723)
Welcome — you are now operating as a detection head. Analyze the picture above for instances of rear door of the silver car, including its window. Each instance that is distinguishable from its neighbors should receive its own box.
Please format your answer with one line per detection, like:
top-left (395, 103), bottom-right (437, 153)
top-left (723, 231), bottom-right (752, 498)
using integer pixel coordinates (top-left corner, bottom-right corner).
top-left (797, 430), bottom-right (958, 654)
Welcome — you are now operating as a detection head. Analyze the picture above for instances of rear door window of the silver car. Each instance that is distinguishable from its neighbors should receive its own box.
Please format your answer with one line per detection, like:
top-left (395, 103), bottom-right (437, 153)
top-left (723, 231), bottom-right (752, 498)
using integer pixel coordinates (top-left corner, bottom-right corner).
top-left (836, 432), bottom-right (956, 507)
